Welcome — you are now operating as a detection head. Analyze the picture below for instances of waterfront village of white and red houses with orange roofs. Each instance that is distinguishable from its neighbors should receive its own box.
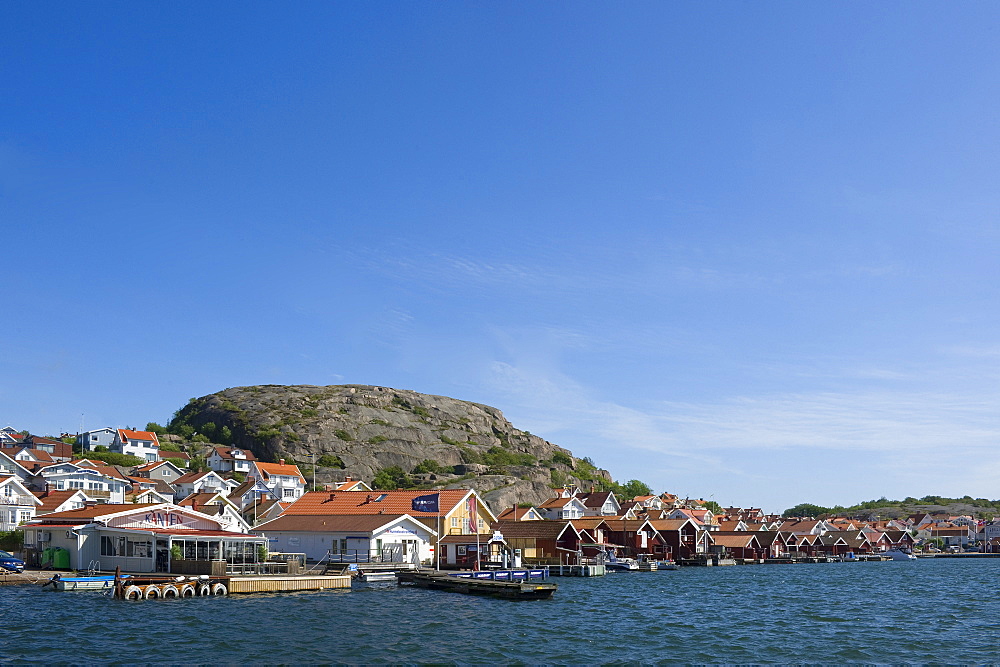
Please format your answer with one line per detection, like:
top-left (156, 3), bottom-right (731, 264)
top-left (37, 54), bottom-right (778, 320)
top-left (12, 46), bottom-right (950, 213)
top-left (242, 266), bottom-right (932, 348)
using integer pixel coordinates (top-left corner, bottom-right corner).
top-left (0, 428), bottom-right (1000, 588)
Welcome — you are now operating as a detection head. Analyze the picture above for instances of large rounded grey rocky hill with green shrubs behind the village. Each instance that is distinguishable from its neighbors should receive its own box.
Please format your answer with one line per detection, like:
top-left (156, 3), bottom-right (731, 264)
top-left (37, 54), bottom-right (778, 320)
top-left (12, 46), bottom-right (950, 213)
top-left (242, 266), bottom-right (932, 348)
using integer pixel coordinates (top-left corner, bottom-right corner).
top-left (168, 385), bottom-right (611, 510)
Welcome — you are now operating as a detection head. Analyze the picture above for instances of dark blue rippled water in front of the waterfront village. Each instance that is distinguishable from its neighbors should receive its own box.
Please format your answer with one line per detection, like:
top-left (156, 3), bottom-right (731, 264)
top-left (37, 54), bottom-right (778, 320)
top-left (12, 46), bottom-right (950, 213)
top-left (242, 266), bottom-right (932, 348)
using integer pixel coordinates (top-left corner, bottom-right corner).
top-left (0, 559), bottom-right (1000, 664)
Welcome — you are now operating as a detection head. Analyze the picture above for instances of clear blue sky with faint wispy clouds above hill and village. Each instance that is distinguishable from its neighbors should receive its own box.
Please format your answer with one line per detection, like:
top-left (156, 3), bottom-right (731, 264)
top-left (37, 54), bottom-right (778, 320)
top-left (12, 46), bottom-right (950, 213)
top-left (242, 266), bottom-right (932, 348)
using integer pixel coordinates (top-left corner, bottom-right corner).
top-left (0, 2), bottom-right (1000, 511)
